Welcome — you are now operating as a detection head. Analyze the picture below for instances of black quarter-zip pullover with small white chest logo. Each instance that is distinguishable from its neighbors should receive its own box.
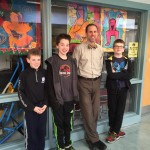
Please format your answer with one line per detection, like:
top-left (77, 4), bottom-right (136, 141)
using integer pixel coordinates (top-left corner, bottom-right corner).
top-left (18, 67), bottom-right (47, 111)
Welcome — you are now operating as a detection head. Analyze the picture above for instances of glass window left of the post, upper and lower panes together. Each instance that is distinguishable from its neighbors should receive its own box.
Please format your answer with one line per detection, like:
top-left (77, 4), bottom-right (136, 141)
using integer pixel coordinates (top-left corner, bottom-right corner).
top-left (0, 0), bottom-right (42, 144)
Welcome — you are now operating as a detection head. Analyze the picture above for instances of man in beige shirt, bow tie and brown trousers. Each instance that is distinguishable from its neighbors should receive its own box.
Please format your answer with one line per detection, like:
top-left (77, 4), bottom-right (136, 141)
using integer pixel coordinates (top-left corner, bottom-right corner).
top-left (73, 24), bottom-right (106, 150)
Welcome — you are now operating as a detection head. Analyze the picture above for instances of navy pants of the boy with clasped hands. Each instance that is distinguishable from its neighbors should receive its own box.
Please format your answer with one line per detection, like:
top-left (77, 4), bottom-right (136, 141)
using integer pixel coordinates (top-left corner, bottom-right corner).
top-left (25, 108), bottom-right (47, 150)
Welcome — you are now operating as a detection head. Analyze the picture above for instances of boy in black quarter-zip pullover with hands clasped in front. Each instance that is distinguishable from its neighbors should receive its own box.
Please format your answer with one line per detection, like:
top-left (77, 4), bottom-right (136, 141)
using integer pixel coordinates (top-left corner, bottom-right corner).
top-left (18, 49), bottom-right (47, 150)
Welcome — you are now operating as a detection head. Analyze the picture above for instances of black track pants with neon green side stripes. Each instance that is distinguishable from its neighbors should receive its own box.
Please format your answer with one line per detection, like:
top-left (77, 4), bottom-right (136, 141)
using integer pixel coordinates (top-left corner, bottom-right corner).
top-left (53, 101), bottom-right (74, 148)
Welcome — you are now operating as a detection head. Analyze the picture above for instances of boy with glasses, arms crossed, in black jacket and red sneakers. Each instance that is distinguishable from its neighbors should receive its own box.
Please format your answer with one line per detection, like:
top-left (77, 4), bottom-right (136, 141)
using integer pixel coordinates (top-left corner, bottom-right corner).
top-left (106, 39), bottom-right (132, 143)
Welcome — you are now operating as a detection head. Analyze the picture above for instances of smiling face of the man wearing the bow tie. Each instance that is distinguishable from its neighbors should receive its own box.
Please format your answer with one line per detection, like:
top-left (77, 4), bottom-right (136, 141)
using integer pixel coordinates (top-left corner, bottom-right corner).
top-left (86, 26), bottom-right (98, 43)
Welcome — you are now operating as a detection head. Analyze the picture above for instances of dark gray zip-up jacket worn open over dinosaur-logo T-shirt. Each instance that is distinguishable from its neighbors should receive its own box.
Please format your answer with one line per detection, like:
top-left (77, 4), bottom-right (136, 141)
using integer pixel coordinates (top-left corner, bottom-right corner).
top-left (45, 55), bottom-right (79, 108)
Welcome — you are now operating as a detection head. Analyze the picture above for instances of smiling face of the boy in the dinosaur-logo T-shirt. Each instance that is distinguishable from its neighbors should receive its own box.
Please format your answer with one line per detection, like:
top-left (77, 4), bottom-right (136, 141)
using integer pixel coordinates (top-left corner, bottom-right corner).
top-left (56, 39), bottom-right (69, 55)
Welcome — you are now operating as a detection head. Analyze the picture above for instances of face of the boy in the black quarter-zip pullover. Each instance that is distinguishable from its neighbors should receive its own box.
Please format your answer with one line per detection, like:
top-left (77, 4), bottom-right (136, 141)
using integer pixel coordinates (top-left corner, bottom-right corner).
top-left (27, 55), bottom-right (41, 69)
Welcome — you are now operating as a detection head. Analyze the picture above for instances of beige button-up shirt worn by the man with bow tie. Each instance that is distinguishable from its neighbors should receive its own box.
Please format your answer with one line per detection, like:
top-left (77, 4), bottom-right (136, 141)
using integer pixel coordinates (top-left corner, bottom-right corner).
top-left (73, 42), bottom-right (104, 78)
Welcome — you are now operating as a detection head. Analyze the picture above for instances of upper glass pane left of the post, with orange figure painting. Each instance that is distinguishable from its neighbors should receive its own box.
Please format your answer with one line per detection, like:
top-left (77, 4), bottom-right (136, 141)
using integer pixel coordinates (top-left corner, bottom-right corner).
top-left (0, 0), bottom-right (42, 94)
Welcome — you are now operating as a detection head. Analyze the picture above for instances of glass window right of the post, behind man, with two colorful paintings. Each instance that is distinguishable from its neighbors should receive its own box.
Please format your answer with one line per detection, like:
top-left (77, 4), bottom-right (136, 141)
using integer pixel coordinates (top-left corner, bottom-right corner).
top-left (51, 0), bottom-right (141, 127)
